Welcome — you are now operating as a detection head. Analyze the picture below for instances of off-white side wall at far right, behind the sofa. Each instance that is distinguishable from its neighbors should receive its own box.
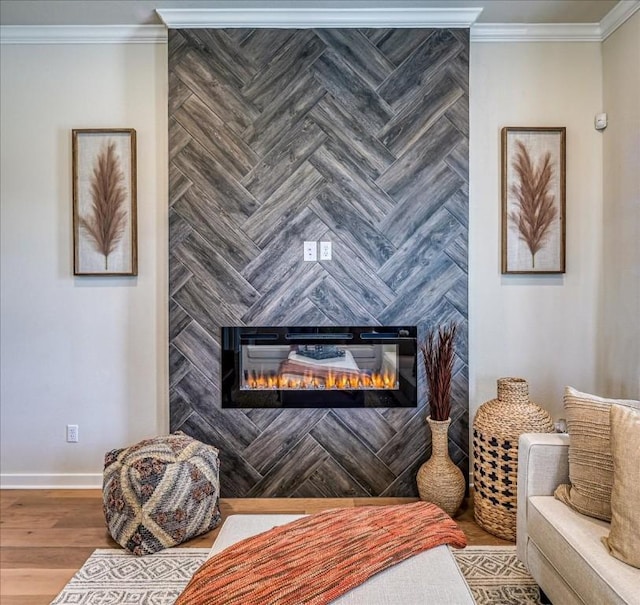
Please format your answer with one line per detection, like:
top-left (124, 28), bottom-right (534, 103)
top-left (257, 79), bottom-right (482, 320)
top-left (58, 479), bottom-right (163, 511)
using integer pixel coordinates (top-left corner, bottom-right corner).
top-left (597, 11), bottom-right (640, 399)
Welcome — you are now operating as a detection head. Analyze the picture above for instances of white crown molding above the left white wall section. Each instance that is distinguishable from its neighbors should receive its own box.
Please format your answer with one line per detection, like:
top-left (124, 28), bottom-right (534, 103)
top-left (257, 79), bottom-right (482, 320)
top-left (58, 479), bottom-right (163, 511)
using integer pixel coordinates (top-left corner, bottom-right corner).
top-left (0, 25), bottom-right (167, 44)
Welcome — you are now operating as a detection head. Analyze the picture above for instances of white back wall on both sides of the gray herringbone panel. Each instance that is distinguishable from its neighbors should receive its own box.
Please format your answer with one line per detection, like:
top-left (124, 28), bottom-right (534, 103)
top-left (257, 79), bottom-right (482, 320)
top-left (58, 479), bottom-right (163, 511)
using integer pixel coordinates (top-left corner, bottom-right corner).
top-left (0, 30), bottom-right (632, 485)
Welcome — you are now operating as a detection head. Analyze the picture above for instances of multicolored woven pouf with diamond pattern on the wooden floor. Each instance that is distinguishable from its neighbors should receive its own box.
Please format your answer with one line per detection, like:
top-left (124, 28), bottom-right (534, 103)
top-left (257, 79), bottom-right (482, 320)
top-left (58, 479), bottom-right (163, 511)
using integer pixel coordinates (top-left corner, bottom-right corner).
top-left (102, 432), bottom-right (220, 555)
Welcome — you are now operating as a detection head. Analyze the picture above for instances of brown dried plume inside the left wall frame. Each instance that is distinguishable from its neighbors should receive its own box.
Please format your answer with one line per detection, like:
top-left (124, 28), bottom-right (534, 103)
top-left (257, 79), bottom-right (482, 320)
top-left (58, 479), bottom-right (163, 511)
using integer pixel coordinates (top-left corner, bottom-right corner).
top-left (80, 142), bottom-right (127, 270)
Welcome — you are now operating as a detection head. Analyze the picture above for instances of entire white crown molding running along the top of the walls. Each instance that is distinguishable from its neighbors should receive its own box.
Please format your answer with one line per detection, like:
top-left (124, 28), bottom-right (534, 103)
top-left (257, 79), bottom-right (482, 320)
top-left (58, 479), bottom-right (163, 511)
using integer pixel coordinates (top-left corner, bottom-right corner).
top-left (0, 0), bottom-right (640, 44)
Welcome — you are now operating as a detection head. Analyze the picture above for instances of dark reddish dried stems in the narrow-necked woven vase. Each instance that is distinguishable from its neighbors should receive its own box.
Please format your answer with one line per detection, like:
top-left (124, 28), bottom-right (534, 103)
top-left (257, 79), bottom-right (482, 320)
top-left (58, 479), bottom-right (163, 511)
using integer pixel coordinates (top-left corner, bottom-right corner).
top-left (420, 323), bottom-right (458, 421)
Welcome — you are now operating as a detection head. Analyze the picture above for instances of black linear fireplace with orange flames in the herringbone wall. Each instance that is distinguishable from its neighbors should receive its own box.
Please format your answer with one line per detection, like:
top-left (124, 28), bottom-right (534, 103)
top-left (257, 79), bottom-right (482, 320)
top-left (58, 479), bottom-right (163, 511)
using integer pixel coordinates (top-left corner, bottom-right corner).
top-left (221, 326), bottom-right (417, 408)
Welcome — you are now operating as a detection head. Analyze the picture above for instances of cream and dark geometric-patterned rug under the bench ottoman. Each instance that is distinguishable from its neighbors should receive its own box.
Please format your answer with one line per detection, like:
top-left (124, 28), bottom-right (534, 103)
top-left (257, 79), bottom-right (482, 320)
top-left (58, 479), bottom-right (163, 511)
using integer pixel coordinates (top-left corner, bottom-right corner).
top-left (51, 546), bottom-right (539, 605)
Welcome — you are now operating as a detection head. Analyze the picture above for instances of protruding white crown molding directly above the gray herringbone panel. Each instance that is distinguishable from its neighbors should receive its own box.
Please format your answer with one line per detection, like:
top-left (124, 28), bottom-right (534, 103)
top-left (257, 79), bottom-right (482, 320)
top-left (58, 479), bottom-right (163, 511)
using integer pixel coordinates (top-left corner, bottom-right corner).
top-left (156, 8), bottom-right (482, 29)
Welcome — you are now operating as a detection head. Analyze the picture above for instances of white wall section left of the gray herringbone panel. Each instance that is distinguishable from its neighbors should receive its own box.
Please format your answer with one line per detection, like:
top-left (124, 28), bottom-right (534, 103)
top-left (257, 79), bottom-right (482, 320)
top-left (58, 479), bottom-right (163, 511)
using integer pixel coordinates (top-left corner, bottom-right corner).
top-left (0, 44), bottom-right (168, 485)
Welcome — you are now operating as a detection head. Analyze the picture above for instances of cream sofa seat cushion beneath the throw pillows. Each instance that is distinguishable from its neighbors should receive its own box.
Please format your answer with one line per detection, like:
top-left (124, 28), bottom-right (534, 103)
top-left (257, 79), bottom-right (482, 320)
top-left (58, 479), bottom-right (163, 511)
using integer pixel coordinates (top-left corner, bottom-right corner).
top-left (527, 496), bottom-right (640, 605)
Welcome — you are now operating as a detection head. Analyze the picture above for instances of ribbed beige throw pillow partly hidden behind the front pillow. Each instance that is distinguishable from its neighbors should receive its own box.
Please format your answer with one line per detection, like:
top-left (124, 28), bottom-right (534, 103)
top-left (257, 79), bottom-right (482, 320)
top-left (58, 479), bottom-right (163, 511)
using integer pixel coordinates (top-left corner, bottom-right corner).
top-left (555, 387), bottom-right (640, 521)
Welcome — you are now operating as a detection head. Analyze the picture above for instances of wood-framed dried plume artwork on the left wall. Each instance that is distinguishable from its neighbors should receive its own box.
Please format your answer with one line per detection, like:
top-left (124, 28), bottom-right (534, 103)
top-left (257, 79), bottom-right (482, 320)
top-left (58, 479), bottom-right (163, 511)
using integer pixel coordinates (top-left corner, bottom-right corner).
top-left (72, 128), bottom-right (138, 276)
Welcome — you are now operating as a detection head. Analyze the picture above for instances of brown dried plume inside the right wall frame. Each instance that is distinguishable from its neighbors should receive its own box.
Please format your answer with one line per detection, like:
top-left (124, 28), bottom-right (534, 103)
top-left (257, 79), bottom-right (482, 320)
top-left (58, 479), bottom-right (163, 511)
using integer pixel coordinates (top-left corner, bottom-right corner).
top-left (509, 141), bottom-right (558, 268)
